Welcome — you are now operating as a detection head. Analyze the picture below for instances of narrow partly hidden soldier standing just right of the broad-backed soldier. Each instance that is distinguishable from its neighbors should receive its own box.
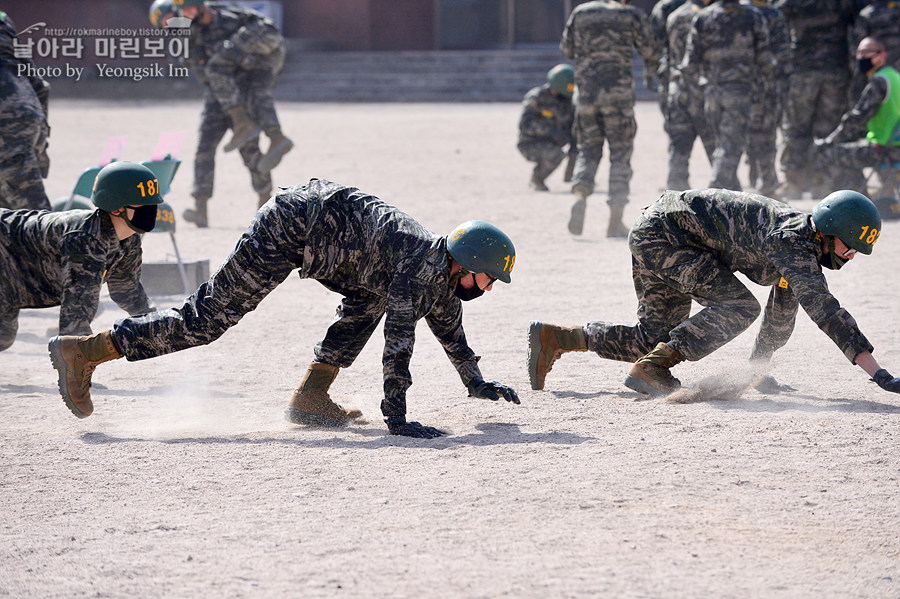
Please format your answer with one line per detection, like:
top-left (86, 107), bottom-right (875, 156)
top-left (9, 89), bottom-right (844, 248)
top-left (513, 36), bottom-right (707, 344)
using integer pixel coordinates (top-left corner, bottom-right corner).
top-left (741, 0), bottom-right (792, 199)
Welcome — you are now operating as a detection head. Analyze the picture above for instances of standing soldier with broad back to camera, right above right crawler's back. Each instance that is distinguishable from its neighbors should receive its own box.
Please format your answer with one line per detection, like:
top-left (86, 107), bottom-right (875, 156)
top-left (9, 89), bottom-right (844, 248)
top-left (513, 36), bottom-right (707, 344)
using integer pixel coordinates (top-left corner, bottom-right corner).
top-left (681, 0), bottom-right (775, 190)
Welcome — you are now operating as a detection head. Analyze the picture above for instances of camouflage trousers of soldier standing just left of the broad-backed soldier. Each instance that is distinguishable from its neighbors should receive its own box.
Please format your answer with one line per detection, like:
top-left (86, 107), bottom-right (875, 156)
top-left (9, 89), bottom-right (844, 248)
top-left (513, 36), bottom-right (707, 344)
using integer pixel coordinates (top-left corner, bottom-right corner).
top-left (665, 81), bottom-right (716, 190)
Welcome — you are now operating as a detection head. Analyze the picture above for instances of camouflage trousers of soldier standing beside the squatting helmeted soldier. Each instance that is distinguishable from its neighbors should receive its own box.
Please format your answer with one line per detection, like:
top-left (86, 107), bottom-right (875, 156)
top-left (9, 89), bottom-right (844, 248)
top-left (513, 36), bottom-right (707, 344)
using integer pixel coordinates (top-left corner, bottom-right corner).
top-left (572, 103), bottom-right (637, 206)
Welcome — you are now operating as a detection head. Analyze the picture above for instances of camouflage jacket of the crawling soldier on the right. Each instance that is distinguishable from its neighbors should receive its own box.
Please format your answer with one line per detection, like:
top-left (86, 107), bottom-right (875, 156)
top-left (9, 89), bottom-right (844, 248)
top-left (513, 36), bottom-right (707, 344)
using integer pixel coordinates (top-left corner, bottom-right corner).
top-left (637, 189), bottom-right (872, 362)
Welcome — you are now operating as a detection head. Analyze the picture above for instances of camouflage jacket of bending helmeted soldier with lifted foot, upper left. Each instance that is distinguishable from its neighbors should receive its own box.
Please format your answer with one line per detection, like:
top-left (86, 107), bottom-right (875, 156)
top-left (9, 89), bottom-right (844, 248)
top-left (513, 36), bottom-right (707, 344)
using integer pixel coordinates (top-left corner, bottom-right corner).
top-left (185, 3), bottom-right (285, 85)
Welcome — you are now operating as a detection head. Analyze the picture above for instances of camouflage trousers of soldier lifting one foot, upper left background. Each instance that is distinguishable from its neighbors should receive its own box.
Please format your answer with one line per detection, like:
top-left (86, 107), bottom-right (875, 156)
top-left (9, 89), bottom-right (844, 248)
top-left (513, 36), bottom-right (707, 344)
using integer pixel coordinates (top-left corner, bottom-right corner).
top-left (191, 94), bottom-right (272, 198)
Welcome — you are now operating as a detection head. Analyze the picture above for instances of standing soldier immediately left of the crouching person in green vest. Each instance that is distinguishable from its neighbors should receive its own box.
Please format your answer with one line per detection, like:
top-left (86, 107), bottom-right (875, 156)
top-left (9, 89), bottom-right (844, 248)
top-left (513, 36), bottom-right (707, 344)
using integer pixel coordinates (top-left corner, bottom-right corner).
top-left (775, 0), bottom-right (856, 199)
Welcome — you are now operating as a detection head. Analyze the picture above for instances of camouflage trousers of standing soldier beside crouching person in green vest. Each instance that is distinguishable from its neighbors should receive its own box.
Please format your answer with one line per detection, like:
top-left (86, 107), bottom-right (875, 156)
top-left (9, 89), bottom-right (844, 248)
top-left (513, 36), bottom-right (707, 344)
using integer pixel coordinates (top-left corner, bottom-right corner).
top-left (781, 71), bottom-right (850, 185)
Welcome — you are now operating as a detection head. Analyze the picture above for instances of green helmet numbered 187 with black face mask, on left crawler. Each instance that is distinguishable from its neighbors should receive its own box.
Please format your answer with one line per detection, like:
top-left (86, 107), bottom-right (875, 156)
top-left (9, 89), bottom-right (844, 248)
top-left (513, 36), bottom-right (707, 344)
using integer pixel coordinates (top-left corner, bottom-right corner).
top-left (91, 161), bottom-right (163, 233)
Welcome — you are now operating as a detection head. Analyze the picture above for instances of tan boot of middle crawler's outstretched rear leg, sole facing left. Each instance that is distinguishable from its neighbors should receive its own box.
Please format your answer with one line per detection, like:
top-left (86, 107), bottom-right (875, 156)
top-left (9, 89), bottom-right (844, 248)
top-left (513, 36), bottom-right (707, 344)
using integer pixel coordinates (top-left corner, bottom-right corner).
top-left (49, 331), bottom-right (122, 418)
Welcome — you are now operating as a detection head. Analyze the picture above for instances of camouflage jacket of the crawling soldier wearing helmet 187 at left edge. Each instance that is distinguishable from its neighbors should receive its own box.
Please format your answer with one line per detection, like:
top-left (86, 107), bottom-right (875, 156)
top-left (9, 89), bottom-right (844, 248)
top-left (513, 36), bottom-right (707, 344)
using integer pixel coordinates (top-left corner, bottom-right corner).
top-left (0, 209), bottom-right (151, 335)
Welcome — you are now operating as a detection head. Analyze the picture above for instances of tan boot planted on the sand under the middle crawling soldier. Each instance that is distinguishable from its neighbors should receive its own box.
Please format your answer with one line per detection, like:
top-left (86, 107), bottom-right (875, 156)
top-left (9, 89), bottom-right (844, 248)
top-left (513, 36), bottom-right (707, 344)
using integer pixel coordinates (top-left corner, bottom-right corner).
top-left (284, 362), bottom-right (362, 427)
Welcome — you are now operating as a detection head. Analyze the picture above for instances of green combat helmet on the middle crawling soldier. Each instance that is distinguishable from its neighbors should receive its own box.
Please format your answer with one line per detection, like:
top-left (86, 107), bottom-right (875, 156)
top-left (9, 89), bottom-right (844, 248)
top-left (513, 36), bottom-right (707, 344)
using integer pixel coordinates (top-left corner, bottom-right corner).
top-left (447, 220), bottom-right (516, 283)
